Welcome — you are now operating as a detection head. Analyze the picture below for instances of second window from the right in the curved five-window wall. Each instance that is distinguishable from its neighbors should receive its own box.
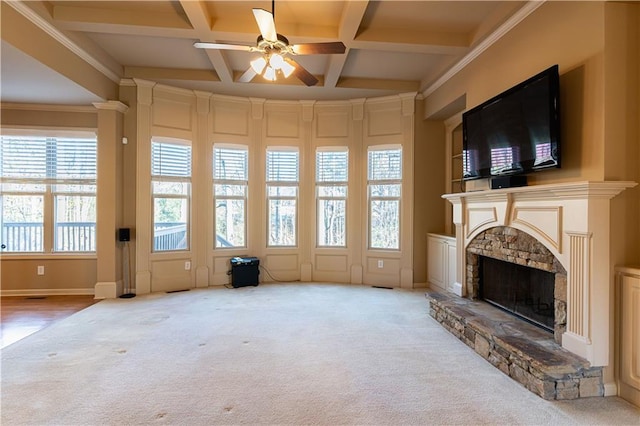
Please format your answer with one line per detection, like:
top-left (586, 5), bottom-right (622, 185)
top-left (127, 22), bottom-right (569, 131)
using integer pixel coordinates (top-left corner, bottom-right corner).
top-left (316, 147), bottom-right (349, 247)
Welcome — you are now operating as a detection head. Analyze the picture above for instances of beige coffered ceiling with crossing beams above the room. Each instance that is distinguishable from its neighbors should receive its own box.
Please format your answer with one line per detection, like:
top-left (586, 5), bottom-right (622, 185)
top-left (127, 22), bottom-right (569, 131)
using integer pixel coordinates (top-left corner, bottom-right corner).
top-left (0, 0), bottom-right (531, 104)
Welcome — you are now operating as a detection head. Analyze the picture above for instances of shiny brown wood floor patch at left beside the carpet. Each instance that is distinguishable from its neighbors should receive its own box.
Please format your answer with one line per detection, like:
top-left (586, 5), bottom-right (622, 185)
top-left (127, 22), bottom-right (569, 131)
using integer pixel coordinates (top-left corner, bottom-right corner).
top-left (0, 296), bottom-right (99, 348)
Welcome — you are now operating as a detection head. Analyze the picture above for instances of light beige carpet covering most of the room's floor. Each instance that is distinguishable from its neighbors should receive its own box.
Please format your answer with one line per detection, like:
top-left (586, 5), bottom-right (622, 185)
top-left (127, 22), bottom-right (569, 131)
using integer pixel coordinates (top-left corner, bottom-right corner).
top-left (0, 284), bottom-right (640, 426)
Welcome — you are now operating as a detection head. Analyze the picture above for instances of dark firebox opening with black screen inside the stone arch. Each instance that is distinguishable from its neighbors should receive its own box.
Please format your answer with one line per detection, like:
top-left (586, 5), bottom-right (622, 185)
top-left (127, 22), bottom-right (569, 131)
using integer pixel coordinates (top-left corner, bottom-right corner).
top-left (479, 256), bottom-right (555, 332)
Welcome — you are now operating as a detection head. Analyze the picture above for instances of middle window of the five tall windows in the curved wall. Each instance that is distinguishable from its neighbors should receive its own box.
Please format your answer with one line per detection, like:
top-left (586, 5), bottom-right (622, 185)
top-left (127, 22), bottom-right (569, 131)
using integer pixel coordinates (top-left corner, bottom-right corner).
top-left (267, 148), bottom-right (300, 247)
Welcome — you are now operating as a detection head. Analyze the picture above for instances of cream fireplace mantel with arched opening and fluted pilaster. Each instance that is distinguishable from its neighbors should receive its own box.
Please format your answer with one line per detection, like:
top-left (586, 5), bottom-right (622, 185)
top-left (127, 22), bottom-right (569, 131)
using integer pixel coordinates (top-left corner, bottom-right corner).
top-left (443, 181), bottom-right (637, 366)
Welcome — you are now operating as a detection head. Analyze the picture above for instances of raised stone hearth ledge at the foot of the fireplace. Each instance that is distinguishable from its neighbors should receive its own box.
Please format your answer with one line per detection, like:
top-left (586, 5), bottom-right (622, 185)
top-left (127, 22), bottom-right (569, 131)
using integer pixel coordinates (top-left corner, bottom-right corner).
top-left (426, 292), bottom-right (604, 400)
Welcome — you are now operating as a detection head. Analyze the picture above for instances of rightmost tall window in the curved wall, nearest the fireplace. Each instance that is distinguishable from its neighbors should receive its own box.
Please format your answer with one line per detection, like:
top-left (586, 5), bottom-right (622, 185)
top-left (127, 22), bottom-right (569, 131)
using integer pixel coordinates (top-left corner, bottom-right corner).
top-left (367, 147), bottom-right (402, 250)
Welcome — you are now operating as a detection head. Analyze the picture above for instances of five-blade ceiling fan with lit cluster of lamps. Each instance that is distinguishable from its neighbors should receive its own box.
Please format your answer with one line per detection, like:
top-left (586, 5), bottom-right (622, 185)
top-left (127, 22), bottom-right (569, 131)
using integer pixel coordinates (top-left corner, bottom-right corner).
top-left (193, 0), bottom-right (345, 86)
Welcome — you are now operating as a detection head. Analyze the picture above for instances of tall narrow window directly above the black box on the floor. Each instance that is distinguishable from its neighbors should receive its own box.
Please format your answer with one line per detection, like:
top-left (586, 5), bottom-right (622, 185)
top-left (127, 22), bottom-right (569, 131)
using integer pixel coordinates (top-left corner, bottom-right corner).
top-left (213, 144), bottom-right (249, 248)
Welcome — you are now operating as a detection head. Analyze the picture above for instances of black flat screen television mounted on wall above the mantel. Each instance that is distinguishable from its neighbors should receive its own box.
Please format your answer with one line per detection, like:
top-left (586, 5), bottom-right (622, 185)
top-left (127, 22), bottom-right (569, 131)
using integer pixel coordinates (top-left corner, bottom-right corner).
top-left (462, 65), bottom-right (560, 180)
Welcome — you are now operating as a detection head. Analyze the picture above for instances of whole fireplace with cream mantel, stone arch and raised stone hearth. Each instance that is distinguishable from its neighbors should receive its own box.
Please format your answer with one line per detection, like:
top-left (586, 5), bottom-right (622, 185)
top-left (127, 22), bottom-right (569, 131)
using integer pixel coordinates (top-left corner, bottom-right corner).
top-left (431, 181), bottom-right (637, 399)
